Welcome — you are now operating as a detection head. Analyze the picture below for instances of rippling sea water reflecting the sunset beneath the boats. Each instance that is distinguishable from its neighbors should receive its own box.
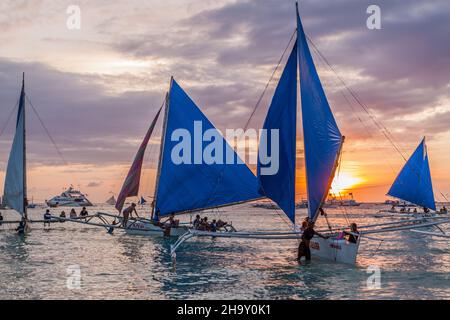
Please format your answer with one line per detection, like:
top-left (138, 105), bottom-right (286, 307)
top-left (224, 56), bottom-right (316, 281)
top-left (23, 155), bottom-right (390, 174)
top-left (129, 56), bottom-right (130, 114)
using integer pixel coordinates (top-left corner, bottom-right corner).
top-left (0, 204), bottom-right (450, 299)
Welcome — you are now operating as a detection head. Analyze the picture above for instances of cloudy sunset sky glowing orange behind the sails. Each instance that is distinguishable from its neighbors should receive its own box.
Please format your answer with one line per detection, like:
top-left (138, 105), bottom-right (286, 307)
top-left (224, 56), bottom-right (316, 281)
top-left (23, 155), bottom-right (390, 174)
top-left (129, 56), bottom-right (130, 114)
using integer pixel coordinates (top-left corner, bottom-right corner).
top-left (0, 0), bottom-right (450, 202)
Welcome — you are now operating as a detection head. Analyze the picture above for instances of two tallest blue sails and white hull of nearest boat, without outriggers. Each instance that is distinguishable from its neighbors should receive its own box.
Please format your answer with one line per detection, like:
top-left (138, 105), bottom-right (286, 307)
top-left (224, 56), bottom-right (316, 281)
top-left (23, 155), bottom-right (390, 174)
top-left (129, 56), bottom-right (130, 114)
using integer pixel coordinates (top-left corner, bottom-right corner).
top-left (258, 4), bottom-right (360, 264)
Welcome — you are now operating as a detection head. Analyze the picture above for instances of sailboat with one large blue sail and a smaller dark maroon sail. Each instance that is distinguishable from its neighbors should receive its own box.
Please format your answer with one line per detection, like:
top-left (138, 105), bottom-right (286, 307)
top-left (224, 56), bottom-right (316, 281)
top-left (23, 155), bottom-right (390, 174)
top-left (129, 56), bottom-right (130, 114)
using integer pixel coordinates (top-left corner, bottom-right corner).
top-left (109, 78), bottom-right (261, 236)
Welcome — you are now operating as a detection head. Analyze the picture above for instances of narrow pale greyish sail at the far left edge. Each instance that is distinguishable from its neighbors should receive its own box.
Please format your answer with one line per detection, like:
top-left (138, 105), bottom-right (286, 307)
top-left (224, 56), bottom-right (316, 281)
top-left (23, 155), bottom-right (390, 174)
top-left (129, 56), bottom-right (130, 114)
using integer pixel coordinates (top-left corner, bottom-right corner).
top-left (3, 75), bottom-right (26, 215)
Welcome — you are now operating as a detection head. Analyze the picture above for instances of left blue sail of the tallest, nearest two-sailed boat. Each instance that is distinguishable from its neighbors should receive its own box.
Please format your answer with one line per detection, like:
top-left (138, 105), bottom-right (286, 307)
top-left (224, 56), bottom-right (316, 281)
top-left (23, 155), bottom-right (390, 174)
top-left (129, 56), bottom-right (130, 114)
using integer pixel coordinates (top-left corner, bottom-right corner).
top-left (258, 44), bottom-right (297, 223)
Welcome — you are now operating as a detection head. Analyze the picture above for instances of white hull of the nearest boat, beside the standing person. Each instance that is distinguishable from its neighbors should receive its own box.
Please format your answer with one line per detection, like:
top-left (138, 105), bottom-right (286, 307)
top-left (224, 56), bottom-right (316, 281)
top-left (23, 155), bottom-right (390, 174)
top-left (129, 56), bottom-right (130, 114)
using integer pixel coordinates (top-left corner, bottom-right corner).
top-left (310, 237), bottom-right (360, 264)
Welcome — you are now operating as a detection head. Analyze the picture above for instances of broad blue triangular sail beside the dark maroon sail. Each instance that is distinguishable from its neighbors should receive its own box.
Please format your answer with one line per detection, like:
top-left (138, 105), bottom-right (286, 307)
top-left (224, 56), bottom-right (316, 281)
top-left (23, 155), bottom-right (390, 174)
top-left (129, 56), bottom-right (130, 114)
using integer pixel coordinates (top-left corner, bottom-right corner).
top-left (155, 80), bottom-right (260, 217)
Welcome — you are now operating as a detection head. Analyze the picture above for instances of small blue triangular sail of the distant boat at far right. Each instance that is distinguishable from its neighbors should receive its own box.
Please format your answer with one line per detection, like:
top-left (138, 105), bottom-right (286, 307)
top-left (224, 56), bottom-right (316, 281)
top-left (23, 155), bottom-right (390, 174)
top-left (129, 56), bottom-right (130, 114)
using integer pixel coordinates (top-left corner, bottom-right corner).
top-left (388, 138), bottom-right (436, 211)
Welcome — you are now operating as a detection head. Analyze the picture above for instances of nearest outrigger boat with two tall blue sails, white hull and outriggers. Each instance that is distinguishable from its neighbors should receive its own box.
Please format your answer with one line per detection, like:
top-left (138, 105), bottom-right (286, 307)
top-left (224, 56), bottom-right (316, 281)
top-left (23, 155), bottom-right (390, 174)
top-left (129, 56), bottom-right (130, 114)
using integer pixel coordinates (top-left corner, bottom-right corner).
top-left (171, 4), bottom-right (450, 264)
